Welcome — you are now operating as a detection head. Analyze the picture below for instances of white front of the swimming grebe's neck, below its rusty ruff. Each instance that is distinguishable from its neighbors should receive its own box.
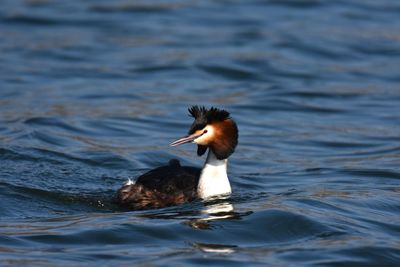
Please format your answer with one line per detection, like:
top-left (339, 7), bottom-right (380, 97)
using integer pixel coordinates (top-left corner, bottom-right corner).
top-left (197, 149), bottom-right (232, 199)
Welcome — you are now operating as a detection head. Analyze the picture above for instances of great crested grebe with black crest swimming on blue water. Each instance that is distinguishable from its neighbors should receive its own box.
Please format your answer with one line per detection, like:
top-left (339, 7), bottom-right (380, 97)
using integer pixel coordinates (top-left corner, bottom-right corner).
top-left (116, 106), bottom-right (239, 209)
